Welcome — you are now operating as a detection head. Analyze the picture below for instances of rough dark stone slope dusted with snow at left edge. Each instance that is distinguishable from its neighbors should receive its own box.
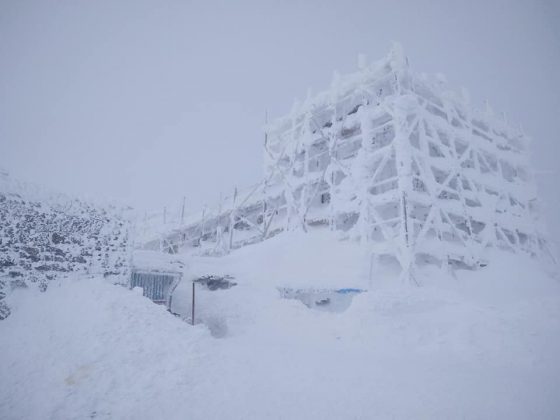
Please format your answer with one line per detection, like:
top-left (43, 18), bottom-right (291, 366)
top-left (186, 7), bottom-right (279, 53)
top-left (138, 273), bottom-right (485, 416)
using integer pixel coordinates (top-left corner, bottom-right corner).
top-left (0, 172), bottom-right (130, 319)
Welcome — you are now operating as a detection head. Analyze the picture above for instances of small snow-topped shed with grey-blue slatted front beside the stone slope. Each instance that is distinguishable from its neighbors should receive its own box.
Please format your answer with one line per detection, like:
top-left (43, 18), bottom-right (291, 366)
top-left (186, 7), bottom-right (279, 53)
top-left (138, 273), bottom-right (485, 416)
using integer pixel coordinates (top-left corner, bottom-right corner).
top-left (129, 251), bottom-right (184, 308)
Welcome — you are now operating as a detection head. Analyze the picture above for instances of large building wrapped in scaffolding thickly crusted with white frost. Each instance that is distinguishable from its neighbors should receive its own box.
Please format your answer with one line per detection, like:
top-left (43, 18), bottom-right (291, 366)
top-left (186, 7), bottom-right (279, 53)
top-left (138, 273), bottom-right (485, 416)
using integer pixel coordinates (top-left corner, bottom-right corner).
top-left (147, 46), bottom-right (548, 278)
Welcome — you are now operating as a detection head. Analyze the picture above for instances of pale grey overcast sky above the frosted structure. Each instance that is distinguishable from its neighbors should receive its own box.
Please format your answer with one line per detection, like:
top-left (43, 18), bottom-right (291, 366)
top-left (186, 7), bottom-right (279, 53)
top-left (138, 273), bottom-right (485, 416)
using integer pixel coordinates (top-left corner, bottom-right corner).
top-left (0, 0), bottom-right (560, 237)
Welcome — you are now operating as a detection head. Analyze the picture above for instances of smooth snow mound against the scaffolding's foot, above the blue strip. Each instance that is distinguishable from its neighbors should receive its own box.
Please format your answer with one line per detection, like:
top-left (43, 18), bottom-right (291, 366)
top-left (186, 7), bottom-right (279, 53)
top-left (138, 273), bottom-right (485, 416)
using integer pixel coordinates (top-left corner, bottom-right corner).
top-left (187, 230), bottom-right (369, 289)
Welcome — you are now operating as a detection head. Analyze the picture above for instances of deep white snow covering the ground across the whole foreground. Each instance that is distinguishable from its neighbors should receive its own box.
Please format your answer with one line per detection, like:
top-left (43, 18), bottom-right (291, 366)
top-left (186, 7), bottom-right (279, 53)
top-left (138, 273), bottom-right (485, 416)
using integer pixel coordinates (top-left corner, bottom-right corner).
top-left (0, 231), bottom-right (560, 419)
